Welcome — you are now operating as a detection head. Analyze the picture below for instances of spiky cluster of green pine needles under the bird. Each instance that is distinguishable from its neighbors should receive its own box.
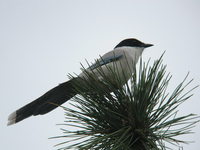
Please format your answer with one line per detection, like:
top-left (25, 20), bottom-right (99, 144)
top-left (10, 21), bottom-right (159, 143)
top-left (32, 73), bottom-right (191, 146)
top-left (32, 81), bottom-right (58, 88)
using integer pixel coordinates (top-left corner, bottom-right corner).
top-left (51, 55), bottom-right (199, 150)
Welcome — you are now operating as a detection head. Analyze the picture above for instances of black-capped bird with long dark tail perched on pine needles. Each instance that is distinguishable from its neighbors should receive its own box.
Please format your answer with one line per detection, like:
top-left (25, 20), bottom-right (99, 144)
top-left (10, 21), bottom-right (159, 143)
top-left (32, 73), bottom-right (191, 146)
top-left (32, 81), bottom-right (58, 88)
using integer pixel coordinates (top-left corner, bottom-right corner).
top-left (7, 38), bottom-right (153, 125)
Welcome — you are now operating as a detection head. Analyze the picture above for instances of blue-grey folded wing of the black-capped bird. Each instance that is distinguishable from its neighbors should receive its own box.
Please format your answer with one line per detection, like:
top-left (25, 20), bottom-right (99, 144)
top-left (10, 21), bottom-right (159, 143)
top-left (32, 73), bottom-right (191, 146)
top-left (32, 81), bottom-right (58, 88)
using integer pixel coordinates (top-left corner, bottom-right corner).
top-left (89, 53), bottom-right (123, 70)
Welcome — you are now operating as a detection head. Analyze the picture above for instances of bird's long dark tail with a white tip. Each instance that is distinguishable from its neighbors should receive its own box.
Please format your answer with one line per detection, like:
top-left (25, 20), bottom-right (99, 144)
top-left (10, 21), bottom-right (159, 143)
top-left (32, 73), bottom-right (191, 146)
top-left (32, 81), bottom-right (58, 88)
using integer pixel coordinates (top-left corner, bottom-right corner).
top-left (7, 78), bottom-right (77, 125)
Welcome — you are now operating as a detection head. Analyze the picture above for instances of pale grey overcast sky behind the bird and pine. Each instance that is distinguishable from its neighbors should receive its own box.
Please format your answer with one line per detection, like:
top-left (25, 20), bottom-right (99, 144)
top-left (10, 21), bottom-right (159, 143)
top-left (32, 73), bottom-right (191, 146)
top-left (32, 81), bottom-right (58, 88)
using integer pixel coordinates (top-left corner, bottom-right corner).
top-left (0, 0), bottom-right (200, 150)
